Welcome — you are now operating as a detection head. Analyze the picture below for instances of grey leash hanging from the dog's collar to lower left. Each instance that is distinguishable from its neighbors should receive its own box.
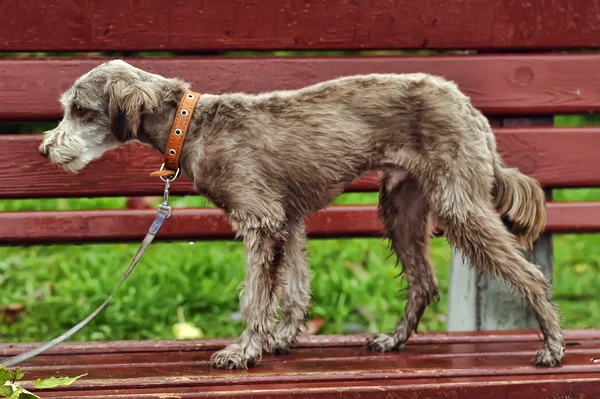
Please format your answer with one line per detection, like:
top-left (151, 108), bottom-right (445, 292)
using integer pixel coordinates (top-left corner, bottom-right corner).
top-left (0, 179), bottom-right (176, 367)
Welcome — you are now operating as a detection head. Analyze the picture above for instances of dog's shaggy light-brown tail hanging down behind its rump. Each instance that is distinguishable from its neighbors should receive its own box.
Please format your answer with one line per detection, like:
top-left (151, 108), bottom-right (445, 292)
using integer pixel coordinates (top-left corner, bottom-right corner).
top-left (487, 132), bottom-right (546, 249)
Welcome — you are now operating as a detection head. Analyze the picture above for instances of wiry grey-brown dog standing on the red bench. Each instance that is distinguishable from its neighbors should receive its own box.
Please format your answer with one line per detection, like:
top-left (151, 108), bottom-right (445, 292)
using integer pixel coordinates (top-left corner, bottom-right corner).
top-left (40, 60), bottom-right (564, 368)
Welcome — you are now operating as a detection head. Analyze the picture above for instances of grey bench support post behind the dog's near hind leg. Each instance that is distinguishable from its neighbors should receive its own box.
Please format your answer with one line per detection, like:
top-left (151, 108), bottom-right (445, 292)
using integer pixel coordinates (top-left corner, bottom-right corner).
top-left (446, 116), bottom-right (553, 331)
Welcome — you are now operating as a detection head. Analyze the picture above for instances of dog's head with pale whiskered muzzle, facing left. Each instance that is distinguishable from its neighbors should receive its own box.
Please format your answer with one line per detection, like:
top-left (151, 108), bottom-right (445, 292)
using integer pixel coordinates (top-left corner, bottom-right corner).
top-left (39, 60), bottom-right (160, 173)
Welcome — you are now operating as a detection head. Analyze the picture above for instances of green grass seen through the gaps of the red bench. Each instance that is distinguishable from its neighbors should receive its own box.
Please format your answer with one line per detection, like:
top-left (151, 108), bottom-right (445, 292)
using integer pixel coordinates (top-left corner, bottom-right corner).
top-left (0, 117), bottom-right (600, 342)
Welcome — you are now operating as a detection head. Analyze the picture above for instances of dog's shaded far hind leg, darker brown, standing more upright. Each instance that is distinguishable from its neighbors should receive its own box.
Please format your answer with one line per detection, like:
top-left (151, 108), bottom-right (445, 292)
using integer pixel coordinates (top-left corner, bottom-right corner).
top-left (367, 171), bottom-right (438, 351)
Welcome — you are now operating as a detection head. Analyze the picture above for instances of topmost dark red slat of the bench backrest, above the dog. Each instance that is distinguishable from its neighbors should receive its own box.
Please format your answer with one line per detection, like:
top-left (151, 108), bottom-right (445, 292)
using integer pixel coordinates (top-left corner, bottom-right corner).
top-left (0, 0), bottom-right (600, 51)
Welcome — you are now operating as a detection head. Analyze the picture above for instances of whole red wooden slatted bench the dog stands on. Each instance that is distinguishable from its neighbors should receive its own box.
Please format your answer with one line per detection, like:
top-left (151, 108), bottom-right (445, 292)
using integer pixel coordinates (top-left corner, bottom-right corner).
top-left (0, 0), bottom-right (600, 398)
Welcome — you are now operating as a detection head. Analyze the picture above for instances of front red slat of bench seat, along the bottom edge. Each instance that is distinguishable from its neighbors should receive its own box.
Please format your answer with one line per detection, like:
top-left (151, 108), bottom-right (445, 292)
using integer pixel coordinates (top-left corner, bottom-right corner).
top-left (27, 373), bottom-right (600, 399)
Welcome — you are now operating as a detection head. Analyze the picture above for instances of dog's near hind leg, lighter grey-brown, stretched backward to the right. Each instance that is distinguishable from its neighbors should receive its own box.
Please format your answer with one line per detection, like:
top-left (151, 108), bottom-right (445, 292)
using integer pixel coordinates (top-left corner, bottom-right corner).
top-left (428, 168), bottom-right (565, 366)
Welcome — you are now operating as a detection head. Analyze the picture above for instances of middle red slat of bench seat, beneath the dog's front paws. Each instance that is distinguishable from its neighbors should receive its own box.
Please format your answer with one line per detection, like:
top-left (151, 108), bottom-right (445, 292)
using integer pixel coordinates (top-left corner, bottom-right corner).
top-left (10, 350), bottom-right (600, 389)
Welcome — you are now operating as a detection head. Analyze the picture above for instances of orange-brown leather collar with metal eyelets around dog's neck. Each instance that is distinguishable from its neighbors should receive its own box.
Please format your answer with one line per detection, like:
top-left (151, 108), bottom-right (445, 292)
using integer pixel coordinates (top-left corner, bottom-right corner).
top-left (150, 90), bottom-right (201, 180)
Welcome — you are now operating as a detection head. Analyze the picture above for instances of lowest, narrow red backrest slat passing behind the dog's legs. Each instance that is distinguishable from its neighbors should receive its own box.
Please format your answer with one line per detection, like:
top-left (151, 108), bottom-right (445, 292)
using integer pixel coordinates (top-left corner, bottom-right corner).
top-left (0, 206), bottom-right (379, 244)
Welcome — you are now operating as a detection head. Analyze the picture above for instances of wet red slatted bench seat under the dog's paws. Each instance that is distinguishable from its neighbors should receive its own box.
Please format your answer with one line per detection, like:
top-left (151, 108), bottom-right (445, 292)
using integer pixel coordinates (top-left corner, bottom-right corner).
top-left (0, 329), bottom-right (600, 399)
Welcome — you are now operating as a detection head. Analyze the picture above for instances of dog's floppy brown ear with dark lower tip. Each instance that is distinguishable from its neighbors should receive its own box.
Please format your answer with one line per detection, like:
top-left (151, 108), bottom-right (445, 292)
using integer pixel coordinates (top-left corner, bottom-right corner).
top-left (106, 78), bottom-right (158, 142)
